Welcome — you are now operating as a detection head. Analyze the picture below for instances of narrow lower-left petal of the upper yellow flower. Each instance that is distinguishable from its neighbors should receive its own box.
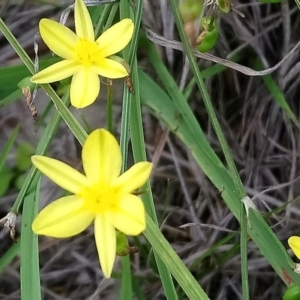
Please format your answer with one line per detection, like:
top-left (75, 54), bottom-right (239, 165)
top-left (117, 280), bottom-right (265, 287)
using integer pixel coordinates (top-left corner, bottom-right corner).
top-left (30, 60), bottom-right (79, 84)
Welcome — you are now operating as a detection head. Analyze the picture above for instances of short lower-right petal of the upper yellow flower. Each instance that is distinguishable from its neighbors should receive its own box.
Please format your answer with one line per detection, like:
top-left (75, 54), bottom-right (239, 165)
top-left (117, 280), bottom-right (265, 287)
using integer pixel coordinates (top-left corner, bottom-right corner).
top-left (94, 58), bottom-right (128, 79)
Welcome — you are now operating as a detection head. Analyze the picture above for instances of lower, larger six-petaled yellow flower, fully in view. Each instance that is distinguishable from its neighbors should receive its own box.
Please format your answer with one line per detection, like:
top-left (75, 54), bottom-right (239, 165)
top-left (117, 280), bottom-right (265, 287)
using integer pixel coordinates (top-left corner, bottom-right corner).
top-left (32, 129), bottom-right (152, 277)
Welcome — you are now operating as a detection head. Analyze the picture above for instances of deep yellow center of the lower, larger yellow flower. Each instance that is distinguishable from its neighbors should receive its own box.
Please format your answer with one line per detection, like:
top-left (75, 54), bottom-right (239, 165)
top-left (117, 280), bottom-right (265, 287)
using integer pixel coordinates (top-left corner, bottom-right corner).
top-left (78, 184), bottom-right (120, 214)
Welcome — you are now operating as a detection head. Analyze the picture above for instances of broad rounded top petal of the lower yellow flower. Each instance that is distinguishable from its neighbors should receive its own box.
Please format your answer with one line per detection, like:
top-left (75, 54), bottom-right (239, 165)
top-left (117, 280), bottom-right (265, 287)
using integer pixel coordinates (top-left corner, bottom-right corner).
top-left (82, 129), bottom-right (122, 184)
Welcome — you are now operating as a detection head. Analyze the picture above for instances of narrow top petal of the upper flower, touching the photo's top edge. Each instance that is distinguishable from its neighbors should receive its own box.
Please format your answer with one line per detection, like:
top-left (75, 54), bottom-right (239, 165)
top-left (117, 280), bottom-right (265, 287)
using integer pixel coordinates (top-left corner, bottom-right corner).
top-left (74, 0), bottom-right (95, 41)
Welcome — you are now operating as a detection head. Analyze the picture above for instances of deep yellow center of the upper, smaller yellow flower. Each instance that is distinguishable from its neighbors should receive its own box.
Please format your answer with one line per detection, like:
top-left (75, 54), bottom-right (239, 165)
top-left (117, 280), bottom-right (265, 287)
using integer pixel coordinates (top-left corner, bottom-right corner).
top-left (75, 38), bottom-right (102, 67)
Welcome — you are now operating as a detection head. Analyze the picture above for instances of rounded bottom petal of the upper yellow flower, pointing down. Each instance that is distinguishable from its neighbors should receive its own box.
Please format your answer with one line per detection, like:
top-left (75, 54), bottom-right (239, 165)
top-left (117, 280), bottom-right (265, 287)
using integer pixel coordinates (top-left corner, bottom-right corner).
top-left (70, 66), bottom-right (100, 108)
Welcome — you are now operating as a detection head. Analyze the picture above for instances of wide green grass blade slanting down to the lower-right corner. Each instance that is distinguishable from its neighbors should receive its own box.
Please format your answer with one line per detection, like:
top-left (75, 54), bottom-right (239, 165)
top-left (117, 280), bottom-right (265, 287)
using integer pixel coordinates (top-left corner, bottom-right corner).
top-left (139, 71), bottom-right (300, 285)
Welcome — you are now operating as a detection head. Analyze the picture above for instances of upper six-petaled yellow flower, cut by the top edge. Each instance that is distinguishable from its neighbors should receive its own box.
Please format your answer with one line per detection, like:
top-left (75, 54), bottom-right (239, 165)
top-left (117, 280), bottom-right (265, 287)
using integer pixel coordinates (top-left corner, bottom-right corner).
top-left (31, 0), bottom-right (134, 108)
